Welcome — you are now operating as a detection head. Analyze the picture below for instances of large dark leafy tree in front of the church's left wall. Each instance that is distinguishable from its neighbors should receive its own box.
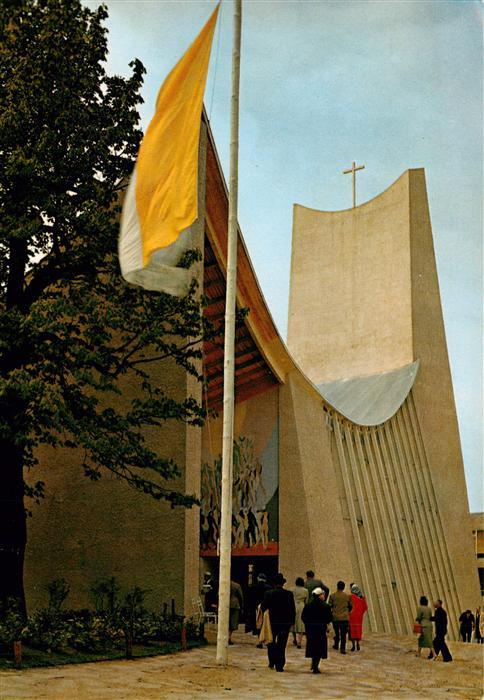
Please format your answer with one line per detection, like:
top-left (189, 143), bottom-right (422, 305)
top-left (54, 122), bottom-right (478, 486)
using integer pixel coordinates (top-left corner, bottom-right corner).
top-left (0, 0), bottom-right (212, 612)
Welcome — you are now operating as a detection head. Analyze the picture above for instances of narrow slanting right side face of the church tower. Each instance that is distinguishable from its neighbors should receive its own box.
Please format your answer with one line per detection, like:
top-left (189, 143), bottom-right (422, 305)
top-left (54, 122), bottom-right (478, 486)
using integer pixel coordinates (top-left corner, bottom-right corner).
top-left (408, 169), bottom-right (480, 609)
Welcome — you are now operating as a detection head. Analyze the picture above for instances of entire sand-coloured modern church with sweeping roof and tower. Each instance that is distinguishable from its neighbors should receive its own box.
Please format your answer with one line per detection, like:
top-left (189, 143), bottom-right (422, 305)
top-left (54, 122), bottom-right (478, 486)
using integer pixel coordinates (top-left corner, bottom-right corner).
top-left (25, 115), bottom-right (480, 638)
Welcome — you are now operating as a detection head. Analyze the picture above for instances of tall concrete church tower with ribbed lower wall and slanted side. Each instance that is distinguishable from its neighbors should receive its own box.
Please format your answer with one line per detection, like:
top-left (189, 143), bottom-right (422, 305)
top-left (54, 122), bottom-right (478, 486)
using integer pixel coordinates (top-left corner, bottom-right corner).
top-left (288, 169), bottom-right (479, 637)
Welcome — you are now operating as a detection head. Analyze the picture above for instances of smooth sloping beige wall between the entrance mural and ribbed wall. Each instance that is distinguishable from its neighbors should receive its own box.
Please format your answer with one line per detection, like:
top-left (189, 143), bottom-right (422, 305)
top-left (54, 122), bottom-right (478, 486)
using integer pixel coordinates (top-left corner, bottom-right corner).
top-left (279, 370), bottom-right (356, 590)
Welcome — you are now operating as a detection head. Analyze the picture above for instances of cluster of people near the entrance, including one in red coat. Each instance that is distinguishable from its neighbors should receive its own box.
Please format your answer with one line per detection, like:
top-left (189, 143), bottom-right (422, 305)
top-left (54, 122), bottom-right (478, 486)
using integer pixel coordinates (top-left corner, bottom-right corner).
top-left (253, 571), bottom-right (367, 673)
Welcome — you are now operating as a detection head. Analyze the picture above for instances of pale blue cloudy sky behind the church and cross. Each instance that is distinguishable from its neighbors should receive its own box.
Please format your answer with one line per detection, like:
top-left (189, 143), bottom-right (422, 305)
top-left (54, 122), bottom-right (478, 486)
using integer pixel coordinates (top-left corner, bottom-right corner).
top-left (84, 0), bottom-right (484, 511)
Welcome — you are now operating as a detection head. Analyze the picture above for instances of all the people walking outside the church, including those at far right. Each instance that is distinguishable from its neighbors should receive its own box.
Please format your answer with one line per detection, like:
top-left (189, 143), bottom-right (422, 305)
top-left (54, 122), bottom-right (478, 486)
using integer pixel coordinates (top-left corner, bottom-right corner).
top-left (206, 571), bottom-right (476, 673)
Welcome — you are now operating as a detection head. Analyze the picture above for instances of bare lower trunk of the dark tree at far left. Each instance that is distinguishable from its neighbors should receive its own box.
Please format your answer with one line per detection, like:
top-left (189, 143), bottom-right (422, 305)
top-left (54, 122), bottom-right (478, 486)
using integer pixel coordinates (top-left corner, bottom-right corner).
top-left (0, 440), bottom-right (27, 615)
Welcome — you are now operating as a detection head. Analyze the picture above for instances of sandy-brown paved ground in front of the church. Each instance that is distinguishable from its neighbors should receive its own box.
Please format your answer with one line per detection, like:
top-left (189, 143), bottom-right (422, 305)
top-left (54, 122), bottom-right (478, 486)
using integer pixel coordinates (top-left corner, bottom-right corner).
top-left (0, 632), bottom-right (484, 700)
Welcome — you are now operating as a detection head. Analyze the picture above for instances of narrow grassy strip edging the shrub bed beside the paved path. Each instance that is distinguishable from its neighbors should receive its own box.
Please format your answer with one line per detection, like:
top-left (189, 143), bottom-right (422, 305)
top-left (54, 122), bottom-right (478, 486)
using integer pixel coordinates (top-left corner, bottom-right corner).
top-left (0, 640), bottom-right (206, 670)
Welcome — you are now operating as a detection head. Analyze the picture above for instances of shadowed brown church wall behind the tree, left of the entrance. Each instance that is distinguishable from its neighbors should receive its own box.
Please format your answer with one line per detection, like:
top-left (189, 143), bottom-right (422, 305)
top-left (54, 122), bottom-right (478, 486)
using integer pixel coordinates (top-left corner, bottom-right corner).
top-left (25, 124), bottom-right (207, 612)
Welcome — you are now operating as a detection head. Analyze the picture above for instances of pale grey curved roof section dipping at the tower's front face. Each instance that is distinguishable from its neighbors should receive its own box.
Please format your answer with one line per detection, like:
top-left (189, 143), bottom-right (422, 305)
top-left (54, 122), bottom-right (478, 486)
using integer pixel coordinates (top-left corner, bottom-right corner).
top-left (316, 360), bottom-right (420, 426)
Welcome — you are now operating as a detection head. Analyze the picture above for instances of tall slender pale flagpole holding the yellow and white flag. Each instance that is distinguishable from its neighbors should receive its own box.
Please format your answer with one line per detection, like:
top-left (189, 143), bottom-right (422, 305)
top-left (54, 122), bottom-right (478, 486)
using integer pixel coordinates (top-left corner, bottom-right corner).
top-left (217, 0), bottom-right (242, 666)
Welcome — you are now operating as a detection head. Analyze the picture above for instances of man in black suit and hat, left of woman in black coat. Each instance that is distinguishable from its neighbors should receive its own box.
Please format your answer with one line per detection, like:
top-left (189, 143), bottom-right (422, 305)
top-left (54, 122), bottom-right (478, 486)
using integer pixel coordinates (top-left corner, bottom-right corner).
top-left (261, 574), bottom-right (296, 672)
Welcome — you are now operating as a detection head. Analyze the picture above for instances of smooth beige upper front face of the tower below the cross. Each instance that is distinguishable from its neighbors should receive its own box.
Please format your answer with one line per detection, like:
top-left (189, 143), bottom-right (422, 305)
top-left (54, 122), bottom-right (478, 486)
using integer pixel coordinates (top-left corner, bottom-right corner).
top-left (288, 175), bottom-right (413, 384)
